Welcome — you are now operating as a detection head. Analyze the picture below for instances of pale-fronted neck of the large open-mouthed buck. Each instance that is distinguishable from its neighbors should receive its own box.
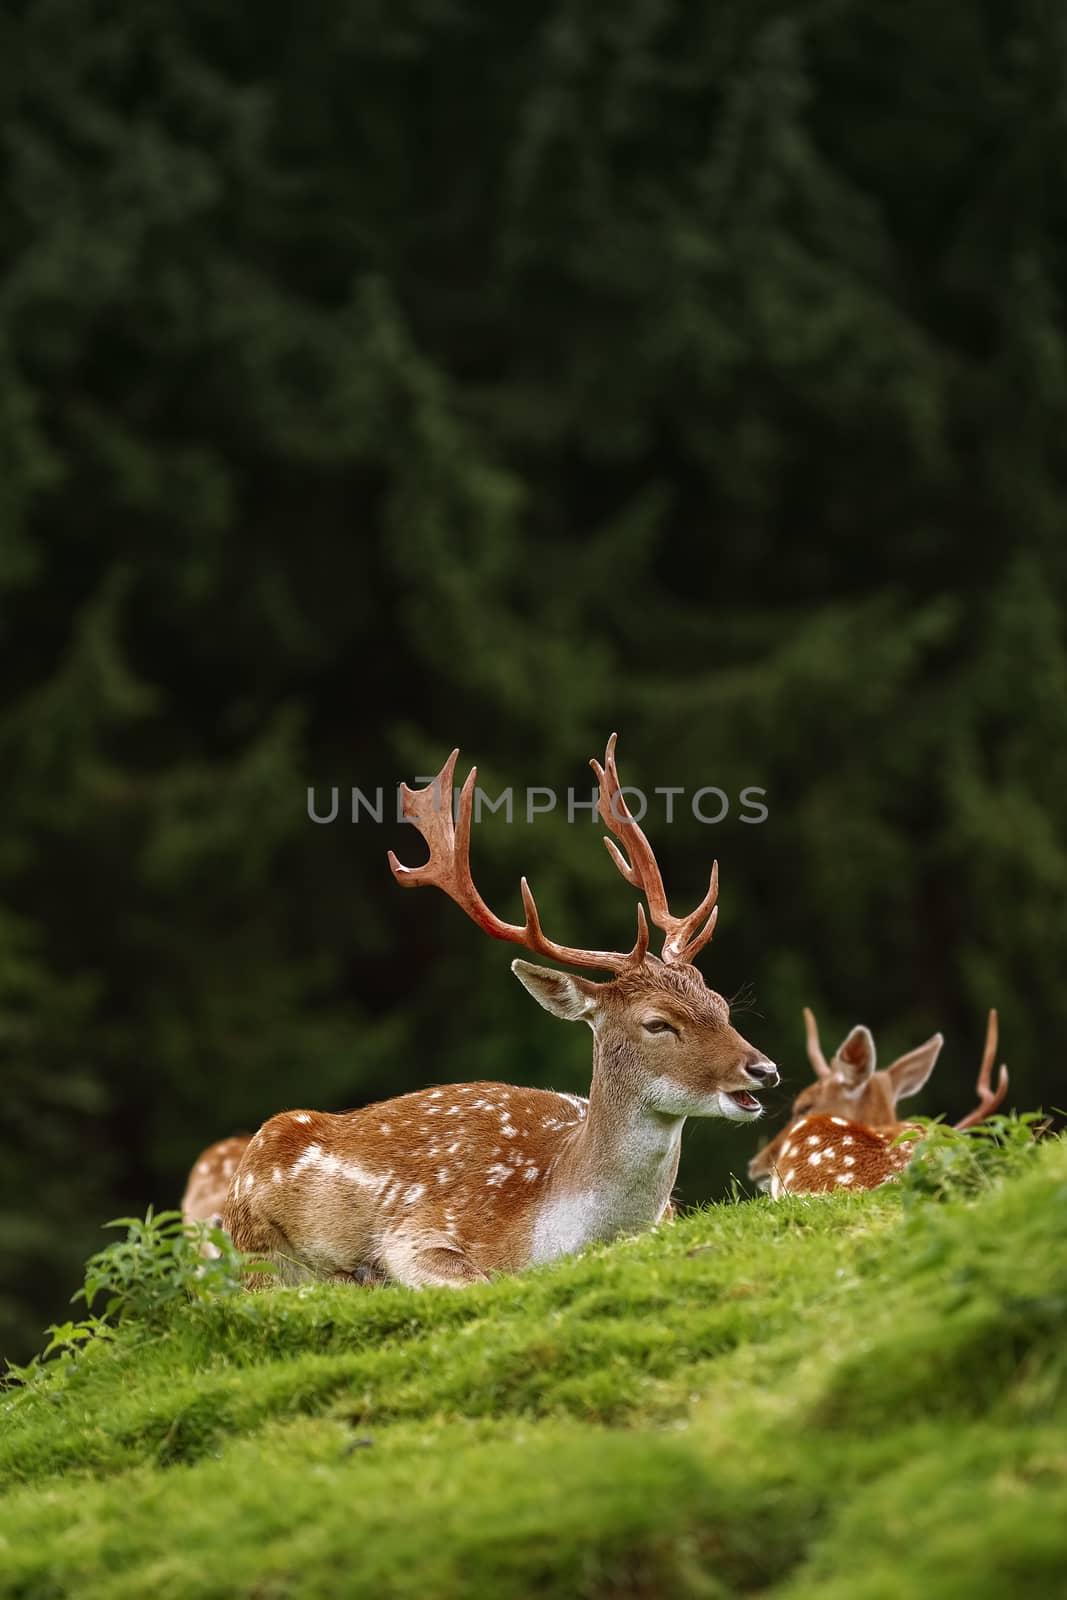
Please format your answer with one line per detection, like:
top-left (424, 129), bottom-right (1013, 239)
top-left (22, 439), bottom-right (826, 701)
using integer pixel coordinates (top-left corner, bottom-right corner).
top-left (533, 1040), bottom-right (685, 1261)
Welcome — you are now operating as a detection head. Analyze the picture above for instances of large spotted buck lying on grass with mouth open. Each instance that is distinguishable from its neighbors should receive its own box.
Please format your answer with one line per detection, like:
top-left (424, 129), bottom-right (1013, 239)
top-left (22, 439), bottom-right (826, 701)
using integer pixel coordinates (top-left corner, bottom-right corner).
top-left (226, 734), bottom-right (777, 1286)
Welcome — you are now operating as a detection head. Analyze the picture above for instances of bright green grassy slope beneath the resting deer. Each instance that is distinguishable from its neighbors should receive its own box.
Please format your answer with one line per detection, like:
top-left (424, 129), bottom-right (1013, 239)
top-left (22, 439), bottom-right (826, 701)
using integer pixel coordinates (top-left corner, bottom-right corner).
top-left (0, 1139), bottom-right (1067, 1600)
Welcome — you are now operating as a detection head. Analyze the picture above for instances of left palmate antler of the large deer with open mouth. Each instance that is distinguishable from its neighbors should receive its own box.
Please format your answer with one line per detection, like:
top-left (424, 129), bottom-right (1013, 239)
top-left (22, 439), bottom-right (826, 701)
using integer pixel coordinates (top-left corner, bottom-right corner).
top-left (389, 750), bottom-right (648, 973)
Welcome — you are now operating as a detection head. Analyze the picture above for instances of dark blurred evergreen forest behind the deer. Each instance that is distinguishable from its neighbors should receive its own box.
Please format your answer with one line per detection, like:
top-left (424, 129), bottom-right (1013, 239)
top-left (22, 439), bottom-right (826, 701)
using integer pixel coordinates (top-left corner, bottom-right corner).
top-left (0, 0), bottom-right (1067, 1355)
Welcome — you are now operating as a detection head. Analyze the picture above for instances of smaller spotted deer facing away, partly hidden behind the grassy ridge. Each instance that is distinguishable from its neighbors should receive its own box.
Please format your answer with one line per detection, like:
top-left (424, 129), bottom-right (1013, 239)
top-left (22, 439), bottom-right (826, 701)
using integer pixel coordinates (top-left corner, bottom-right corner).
top-left (749, 1008), bottom-right (1008, 1200)
